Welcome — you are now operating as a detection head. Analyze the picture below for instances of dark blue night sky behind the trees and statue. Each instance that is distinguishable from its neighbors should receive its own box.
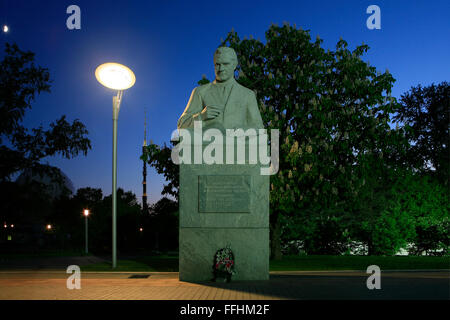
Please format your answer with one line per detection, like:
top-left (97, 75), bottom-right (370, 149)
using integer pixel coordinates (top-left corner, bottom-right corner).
top-left (0, 0), bottom-right (450, 202)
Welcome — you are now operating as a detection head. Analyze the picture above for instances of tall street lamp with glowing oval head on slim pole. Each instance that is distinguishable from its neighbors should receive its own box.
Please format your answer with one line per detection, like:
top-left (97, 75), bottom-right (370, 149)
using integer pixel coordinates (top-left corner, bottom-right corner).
top-left (95, 62), bottom-right (136, 268)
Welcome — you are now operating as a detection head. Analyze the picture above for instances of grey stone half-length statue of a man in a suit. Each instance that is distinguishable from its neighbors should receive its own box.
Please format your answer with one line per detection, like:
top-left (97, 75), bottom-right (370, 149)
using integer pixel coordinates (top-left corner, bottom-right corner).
top-left (178, 47), bottom-right (264, 129)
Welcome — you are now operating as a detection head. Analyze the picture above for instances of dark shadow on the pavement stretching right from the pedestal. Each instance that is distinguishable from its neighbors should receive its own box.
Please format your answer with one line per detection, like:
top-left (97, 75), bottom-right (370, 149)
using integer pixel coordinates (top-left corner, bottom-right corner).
top-left (187, 272), bottom-right (450, 300)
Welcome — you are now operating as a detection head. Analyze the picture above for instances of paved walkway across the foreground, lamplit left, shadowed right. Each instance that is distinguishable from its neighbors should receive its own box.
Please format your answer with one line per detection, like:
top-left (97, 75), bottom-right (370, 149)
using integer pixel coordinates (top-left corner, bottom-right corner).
top-left (0, 269), bottom-right (450, 300)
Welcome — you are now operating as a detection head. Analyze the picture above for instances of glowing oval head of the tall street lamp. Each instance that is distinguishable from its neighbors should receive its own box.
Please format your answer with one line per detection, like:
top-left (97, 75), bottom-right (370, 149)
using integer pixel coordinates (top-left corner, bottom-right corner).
top-left (95, 62), bottom-right (136, 90)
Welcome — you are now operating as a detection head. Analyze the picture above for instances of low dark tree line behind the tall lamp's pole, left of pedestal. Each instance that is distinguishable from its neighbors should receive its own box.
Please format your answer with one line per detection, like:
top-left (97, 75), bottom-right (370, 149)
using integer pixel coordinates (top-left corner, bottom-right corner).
top-left (46, 188), bottom-right (178, 254)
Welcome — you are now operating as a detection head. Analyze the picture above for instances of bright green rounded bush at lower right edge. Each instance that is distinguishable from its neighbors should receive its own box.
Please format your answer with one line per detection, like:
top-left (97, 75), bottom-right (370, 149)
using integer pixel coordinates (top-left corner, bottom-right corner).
top-left (350, 171), bottom-right (449, 255)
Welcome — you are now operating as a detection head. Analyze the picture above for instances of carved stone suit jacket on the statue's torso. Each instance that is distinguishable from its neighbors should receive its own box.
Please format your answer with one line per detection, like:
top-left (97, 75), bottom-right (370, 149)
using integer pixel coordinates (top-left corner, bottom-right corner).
top-left (177, 78), bottom-right (264, 129)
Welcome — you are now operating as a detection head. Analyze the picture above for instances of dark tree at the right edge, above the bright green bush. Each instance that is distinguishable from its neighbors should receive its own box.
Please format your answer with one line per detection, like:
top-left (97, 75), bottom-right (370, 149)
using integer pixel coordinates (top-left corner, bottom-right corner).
top-left (394, 82), bottom-right (450, 185)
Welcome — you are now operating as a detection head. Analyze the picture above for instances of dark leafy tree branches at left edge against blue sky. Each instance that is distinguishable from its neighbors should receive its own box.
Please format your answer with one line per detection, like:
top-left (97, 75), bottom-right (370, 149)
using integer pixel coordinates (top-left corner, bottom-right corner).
top-left (0, 43), bottom-right (91, 182)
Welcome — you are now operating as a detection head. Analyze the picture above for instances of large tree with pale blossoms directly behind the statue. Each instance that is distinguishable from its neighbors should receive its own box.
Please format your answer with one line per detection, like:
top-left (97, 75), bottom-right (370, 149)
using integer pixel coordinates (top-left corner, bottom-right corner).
top-left (218, 24), bottom-right (406, 258)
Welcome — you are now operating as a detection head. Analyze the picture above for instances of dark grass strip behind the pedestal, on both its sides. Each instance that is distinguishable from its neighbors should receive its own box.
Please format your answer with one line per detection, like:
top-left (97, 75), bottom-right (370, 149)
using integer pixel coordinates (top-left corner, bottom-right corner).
top-left (81, 256), bottom-right (450, 272)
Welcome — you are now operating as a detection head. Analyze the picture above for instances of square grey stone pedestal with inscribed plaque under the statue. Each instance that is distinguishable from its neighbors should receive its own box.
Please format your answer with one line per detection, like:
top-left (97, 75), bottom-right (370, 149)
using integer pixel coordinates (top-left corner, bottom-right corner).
top-left (179, 138), bottom-right (269, 281)
